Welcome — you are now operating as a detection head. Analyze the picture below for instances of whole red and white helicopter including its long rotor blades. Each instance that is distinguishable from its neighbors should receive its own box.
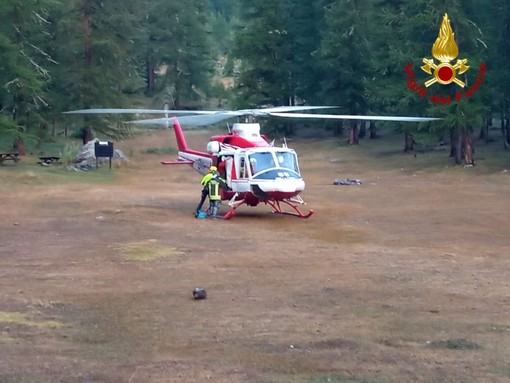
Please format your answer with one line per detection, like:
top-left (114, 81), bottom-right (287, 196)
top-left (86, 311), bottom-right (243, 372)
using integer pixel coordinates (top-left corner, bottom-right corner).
top-left (66, 106), bottom-right (436, 218)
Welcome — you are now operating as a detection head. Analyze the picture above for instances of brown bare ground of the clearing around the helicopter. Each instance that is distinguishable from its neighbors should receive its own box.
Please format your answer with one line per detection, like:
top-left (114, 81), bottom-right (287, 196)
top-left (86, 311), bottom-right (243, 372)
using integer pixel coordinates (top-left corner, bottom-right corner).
top-left (0, 133), bottom-right (510, 383)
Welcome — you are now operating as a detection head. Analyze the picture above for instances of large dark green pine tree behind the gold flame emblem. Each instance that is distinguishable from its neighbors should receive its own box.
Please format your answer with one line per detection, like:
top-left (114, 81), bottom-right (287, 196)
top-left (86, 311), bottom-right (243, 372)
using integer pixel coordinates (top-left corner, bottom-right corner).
top-left (371, 0), bottom-right (485, 164)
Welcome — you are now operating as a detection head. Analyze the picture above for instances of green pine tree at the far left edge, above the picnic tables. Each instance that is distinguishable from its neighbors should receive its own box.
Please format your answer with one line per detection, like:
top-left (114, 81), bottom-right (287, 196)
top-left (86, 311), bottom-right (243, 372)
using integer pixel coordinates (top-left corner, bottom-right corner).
top-left (0, 0), bottom-right (54, 155)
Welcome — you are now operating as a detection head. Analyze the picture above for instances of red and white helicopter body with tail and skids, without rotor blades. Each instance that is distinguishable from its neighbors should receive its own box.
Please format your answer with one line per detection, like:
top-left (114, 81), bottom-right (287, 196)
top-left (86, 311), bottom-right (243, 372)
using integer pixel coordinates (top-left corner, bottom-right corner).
top-left (164, 118), bottom-right (313, 217)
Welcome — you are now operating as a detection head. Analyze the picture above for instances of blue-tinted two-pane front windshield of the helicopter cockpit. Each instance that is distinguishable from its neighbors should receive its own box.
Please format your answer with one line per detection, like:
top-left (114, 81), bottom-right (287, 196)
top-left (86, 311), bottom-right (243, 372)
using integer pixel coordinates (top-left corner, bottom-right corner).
top-left (248, 151), bottom-right (301, 178)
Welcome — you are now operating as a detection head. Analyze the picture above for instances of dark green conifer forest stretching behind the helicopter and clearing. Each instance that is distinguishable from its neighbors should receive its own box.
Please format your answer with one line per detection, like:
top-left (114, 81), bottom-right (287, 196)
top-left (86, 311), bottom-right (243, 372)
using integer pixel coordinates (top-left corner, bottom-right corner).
top-left (0, 0), bottom-right (510, 164)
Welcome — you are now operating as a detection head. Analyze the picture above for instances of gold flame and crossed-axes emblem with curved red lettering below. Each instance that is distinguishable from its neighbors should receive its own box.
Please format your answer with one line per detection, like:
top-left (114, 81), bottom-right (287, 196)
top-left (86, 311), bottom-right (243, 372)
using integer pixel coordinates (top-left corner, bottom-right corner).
top-left (404, 14), bottom-right (487, 104)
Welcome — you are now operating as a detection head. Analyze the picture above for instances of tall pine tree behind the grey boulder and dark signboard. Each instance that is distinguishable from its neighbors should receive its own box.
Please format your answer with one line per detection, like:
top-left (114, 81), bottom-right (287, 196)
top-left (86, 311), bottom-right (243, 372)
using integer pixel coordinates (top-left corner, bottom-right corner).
top-left (52, 0), bottom-right (145, 143)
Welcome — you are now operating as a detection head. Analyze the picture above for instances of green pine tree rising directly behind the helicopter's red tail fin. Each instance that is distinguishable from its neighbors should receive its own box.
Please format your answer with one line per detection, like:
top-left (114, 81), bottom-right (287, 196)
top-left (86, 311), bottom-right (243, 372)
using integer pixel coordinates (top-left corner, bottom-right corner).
top-left (145, 0), bottom-right (217, 108)
